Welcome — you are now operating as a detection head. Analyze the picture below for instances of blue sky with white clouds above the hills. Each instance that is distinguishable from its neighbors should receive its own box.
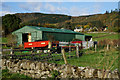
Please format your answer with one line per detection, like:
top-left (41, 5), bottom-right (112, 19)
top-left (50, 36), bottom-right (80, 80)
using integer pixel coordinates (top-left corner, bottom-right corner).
top-left (0, 0), bottom-right (119, 16)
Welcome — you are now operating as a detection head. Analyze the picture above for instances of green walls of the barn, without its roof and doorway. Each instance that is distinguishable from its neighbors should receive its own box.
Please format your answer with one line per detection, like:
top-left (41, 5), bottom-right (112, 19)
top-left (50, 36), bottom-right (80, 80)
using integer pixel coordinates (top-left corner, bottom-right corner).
top-left (12, 26), bottom-right (85, 44)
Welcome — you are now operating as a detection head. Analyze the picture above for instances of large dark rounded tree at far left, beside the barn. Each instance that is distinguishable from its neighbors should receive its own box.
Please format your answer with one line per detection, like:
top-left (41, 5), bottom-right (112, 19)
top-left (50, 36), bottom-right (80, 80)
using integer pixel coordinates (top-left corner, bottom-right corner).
top-left (2, 14), bottom-right (21, 35)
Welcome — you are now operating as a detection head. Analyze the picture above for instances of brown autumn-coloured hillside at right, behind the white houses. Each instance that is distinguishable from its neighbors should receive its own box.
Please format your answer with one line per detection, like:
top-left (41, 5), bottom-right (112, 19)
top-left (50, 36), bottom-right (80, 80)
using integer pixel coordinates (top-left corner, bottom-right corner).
top-left (57, 13), bottom-right (120, 30)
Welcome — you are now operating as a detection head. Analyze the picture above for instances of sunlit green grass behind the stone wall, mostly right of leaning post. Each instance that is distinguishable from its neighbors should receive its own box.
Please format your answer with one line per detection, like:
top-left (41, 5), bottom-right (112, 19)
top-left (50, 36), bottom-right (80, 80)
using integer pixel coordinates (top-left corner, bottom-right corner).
top-left (50, 47), bottom-right (119, 70)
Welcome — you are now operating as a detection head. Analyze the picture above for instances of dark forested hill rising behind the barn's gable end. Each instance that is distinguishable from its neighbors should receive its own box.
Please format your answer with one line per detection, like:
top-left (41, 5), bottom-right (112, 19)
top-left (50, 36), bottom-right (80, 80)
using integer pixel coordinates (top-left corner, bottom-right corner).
top-left (15, 13), bottom-right (71, 24)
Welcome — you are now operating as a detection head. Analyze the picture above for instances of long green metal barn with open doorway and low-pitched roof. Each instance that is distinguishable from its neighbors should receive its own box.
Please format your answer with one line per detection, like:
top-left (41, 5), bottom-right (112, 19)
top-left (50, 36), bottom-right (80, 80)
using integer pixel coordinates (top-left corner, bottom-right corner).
top-left (12, 26), bottom-right (92, 45)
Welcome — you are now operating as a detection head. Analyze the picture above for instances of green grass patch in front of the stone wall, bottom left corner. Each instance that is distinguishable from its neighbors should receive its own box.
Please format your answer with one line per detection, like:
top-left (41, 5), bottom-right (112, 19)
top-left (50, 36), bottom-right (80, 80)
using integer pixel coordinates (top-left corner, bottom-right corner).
top-left (2, 69), bottom-right (32, 80)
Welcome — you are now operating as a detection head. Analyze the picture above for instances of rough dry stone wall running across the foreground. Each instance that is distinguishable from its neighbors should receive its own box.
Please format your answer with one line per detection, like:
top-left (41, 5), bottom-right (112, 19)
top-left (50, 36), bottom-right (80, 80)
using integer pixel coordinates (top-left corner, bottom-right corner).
top-left (2, 59), bottom-right (119, 79)
